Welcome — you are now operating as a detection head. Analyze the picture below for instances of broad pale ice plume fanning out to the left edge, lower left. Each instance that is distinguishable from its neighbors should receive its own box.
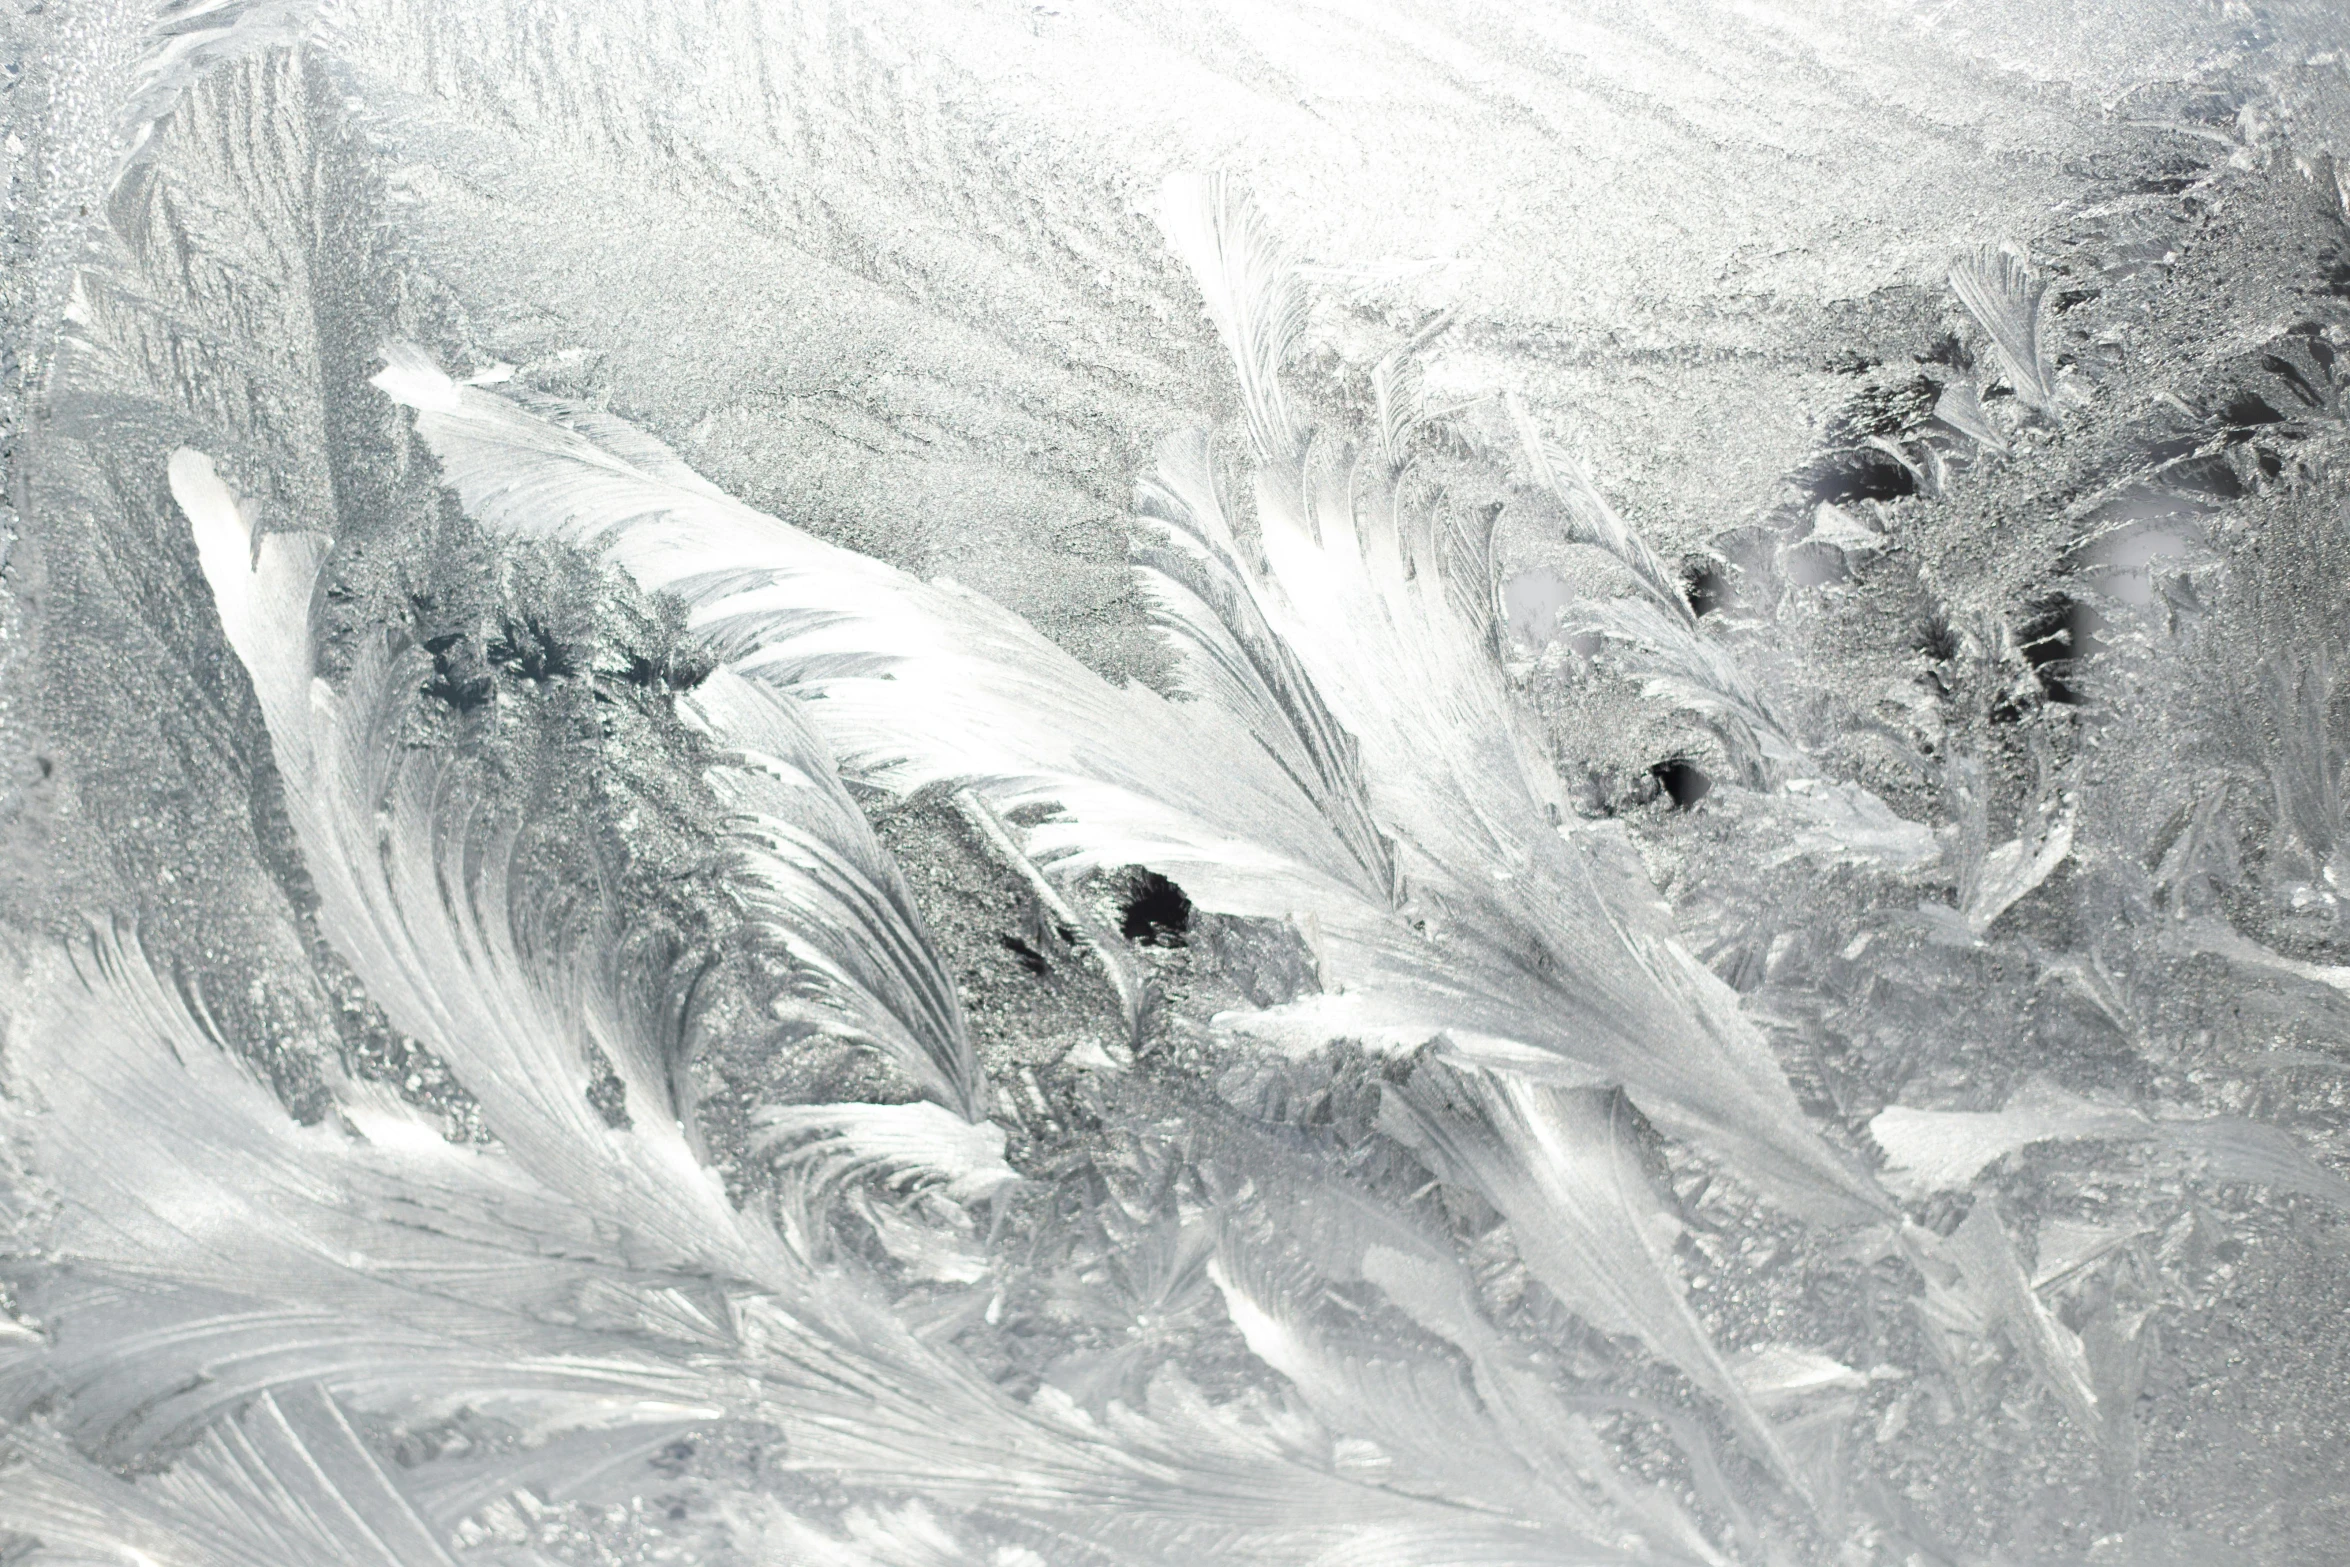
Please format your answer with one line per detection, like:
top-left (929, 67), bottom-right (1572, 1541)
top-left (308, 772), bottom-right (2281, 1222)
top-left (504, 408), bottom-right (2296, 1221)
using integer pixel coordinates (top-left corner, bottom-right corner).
top-left (0, 928), bottom-right (742, 1457)
